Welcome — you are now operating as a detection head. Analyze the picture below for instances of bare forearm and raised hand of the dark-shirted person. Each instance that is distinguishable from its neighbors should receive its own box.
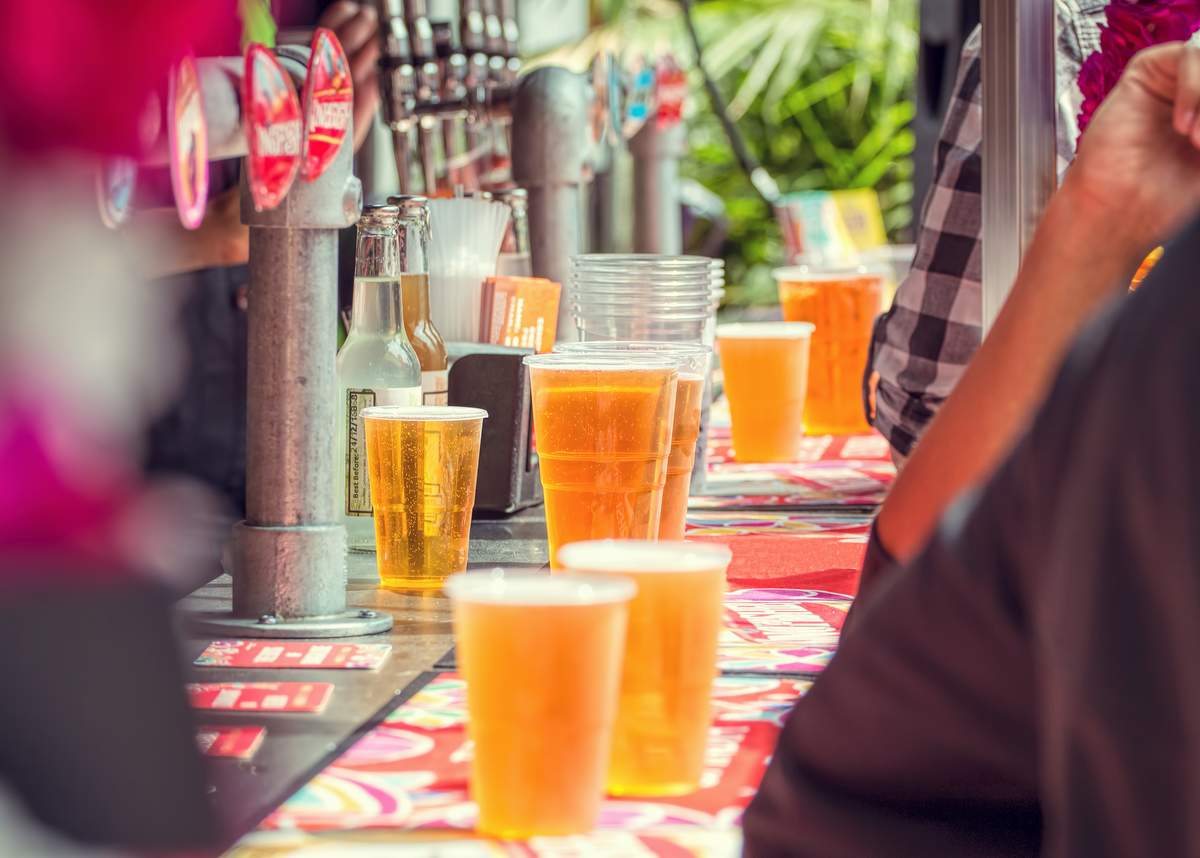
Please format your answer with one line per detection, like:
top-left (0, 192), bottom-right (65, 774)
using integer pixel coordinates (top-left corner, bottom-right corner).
top-left (876, 44), bottom-right (1200, 563)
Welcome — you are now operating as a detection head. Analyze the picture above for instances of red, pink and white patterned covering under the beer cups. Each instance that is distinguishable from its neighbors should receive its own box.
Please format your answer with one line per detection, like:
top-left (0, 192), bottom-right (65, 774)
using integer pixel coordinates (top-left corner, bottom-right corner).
top-left (230, 427), bottom-right (895, 858)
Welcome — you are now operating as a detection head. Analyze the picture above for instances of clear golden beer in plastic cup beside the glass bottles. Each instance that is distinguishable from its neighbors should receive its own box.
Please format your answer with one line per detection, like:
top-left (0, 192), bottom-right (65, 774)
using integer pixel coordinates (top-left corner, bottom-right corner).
top-left (362, 406), bottom-right (487, 590)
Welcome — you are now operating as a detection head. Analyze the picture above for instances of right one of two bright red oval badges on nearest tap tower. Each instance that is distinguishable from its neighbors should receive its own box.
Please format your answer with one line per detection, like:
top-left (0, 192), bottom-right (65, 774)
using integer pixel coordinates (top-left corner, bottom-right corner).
top-left (300, 28), bottom-right (354, 181)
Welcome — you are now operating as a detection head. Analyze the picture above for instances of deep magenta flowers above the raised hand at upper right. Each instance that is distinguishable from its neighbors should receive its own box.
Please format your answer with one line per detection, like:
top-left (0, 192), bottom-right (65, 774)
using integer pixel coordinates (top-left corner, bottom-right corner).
top-left (1079, 0), bottom-right (1200, 136)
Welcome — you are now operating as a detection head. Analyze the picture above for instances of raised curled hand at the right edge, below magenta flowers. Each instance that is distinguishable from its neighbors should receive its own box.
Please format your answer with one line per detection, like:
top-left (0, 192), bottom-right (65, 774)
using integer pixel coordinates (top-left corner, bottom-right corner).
top-left (1063, 42), bottom-right (1200, 270)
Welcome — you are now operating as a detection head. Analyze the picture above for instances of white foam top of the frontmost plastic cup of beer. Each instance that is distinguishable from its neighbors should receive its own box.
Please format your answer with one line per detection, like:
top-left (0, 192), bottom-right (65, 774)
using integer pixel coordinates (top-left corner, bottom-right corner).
top-left (445, 569), bottom-right (637, 607)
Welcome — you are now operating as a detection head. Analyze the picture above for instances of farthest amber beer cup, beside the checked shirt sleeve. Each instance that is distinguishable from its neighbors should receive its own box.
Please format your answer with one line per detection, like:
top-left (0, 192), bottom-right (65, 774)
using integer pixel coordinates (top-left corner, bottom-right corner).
top-left (774, 265), bottom-right (887, 434)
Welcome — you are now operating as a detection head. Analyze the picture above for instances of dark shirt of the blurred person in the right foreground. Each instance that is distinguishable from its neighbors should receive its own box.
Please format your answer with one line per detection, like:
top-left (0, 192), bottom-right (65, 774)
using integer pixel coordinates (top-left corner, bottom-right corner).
top-left (744, 45), bottom-right (1200, 858)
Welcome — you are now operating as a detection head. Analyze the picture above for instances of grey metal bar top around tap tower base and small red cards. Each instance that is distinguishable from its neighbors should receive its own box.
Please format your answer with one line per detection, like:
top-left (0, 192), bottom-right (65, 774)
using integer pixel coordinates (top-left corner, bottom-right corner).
top-left (178, 506), bottom-right (548, 840)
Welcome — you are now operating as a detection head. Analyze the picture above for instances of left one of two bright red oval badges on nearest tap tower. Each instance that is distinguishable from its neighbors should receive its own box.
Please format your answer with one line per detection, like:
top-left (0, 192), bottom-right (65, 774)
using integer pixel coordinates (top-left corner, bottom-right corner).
top-left (241, 44), bottom-right (302, 211)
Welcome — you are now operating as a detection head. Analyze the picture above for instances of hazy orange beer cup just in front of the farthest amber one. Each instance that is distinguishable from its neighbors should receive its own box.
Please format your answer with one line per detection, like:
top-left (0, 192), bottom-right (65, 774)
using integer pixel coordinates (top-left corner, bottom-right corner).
top-left (716, 322), bottom-right (812, 462)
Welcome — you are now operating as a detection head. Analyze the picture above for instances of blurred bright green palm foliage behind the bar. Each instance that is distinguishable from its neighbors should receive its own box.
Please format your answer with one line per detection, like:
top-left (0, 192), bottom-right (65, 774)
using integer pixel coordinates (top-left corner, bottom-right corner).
top-left (544, 0), bottom-right (917, 305)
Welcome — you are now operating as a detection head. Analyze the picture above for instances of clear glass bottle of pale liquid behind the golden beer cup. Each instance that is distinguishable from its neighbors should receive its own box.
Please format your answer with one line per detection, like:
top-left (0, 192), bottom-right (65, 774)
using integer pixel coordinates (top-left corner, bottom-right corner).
top-left (337, 205), bottom-right (421, 551)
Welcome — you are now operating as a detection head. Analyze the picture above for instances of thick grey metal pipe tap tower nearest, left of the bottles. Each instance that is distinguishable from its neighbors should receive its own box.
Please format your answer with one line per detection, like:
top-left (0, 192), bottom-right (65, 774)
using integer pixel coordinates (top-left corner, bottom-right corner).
top-left (182, 49), bottom-right (391, 638)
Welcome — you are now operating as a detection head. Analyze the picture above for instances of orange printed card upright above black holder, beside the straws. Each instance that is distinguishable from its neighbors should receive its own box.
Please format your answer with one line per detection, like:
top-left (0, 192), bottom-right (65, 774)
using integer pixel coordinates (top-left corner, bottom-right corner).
top-left (479, 277), bottom-right (563, 354)
